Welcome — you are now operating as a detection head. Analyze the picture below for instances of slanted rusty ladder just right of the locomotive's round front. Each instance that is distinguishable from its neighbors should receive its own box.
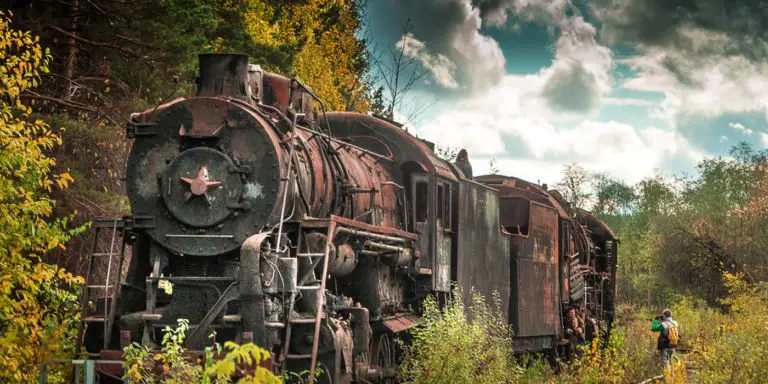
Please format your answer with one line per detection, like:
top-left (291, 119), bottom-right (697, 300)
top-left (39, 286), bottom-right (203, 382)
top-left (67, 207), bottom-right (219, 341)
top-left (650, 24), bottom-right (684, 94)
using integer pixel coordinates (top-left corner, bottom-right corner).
top-left (283, 220), bottom-right (336, 384)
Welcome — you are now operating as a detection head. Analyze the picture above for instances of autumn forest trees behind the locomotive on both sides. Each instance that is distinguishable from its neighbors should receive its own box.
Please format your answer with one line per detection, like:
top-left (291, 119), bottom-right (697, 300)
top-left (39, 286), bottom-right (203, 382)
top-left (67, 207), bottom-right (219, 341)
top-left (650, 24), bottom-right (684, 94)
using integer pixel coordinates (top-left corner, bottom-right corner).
top-left (0, 0), bottom-right (768, 382)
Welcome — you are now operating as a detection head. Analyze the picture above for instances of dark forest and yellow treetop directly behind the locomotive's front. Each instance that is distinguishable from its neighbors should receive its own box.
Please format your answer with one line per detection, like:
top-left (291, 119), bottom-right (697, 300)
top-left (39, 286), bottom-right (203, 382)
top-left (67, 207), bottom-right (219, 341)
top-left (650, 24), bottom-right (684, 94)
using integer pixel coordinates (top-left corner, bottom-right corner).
top-left (5, 0), bottom-right (373, 271)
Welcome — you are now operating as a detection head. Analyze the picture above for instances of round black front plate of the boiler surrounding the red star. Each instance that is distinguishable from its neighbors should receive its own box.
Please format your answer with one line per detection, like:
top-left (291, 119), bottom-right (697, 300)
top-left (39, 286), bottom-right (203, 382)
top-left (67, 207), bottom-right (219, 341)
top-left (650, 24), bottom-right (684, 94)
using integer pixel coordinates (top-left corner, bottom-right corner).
top-left (126, 97), bottom-right (285, 255)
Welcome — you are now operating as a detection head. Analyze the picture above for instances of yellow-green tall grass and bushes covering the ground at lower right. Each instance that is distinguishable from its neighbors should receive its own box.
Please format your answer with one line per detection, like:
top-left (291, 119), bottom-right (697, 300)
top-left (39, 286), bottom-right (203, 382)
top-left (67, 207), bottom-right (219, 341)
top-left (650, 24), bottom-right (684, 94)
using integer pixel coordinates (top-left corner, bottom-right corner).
top-left (400, 275), bottom-right (768, 384)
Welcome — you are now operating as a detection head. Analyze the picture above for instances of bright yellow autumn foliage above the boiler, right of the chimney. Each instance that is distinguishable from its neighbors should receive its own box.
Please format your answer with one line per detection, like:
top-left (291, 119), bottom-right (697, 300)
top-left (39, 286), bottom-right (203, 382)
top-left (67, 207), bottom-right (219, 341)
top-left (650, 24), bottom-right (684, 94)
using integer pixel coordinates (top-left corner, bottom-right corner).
top-left (219, 0), bottom-right (370, 112)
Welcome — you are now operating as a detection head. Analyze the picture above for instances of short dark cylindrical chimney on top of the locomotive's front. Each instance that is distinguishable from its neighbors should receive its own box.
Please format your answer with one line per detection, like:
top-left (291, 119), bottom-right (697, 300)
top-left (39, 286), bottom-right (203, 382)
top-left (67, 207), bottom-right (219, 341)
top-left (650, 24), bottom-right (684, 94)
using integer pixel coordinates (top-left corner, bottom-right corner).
top-left (197, 54), bottom-right (249, 98)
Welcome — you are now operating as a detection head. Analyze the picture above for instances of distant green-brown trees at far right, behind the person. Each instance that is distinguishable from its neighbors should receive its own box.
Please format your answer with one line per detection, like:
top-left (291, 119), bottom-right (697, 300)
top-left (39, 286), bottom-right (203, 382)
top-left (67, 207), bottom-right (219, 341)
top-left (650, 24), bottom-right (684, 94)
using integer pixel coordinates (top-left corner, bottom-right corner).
top-left (558, 143), bottom-right (768, 307)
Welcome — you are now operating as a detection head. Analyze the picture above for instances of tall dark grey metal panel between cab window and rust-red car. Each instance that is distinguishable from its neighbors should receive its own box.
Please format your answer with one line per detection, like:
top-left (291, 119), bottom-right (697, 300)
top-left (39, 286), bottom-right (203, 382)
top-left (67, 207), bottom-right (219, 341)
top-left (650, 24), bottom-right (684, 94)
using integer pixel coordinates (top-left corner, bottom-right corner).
top-left (456, 182), bottom-right (512, 319)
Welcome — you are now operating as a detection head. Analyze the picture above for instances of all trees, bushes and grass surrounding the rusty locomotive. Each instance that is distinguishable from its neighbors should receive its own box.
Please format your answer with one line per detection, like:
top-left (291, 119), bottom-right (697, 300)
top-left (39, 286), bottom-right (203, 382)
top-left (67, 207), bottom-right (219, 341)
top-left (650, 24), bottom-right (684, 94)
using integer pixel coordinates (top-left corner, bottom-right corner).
top-left (0, 0), bottom-right (768, 383)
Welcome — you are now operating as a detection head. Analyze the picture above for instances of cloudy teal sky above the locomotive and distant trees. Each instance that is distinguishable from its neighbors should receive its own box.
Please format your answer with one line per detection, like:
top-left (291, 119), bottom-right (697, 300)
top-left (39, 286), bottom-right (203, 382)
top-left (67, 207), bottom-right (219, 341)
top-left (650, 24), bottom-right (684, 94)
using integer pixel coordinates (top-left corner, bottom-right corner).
top-left (367, 0), bottom-right (768, 183)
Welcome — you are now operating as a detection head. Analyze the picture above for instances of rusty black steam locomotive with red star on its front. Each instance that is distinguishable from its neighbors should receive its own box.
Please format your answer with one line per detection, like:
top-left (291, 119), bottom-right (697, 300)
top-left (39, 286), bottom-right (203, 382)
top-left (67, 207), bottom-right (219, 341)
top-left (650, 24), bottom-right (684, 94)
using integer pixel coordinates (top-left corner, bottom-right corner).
top-left (83, 54), bottom-right (618, 383)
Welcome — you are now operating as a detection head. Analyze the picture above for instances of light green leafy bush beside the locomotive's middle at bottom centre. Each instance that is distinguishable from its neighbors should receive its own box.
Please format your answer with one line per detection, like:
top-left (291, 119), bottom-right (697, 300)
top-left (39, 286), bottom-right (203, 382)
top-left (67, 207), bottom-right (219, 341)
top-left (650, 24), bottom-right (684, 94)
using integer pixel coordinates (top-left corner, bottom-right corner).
top-left (400, 289), bottom-right (522, 384)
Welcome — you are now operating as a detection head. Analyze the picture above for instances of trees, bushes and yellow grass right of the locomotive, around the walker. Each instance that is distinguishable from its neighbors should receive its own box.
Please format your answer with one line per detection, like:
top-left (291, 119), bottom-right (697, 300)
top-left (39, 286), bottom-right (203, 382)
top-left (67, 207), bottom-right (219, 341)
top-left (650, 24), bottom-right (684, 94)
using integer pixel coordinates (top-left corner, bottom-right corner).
top-left (405, 144), bottom-right (768, 383)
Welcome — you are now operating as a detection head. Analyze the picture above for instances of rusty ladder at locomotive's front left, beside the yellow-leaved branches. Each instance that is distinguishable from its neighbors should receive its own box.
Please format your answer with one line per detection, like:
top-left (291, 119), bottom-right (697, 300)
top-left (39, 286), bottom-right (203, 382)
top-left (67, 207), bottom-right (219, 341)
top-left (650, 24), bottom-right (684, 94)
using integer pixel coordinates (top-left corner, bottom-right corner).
top-left (75, 220), bottom-right (126, 354)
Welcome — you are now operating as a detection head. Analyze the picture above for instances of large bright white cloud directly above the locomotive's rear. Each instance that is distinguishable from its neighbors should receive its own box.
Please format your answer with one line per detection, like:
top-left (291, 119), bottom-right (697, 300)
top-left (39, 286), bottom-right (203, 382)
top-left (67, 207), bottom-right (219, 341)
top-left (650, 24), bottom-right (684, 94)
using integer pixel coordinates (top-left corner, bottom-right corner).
top-left (404, 0), bottom-right (704, 183)
